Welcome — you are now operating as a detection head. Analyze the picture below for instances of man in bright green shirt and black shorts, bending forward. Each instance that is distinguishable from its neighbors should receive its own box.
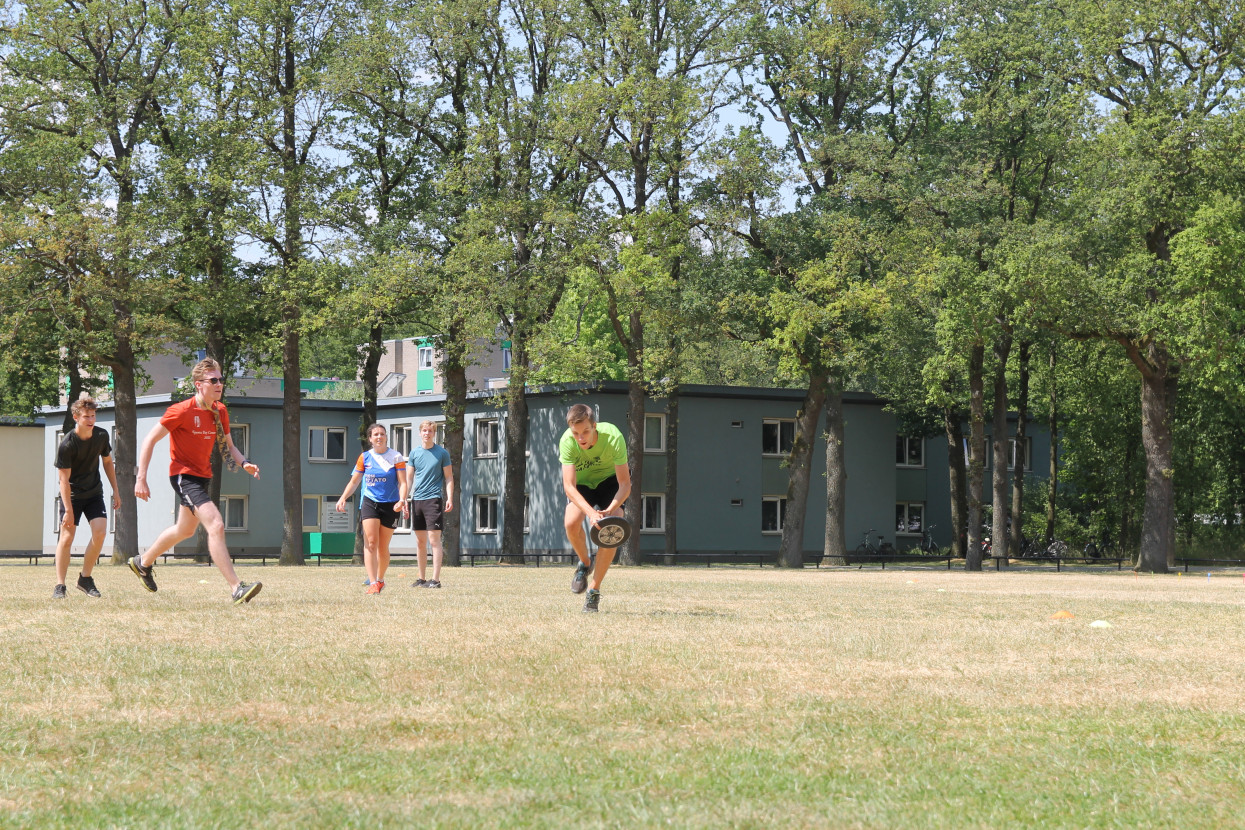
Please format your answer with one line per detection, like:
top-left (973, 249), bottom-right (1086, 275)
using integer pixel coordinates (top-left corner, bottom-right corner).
top-left (558, 403), bottom-right (631, 612)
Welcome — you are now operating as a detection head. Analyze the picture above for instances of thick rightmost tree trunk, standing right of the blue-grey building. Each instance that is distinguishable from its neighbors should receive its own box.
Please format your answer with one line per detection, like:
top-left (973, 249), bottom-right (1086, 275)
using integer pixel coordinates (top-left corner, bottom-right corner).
top-left (1128, 343), bottom-right (1179, 574)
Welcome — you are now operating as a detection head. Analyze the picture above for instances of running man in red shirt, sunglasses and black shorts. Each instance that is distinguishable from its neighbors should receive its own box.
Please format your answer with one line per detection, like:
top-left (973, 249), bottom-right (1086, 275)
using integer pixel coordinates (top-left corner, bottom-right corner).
top-left (129, 357), bottom-right (264, 605)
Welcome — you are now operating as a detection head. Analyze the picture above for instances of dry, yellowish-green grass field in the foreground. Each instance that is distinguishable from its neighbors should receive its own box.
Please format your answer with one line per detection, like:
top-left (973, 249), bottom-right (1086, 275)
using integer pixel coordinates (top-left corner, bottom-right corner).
top-left (0, 561), bottom-right (1245, 828)
